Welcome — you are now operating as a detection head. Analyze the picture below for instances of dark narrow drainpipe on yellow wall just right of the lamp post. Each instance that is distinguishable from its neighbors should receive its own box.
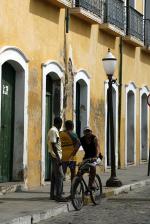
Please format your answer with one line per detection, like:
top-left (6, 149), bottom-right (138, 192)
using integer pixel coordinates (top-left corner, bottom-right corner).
top-left (118, 37), bottom-right (123, 168)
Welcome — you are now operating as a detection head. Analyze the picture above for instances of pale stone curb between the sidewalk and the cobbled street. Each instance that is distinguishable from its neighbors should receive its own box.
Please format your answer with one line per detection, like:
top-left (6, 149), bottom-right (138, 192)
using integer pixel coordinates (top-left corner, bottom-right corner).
top-left (1, 179), bottom-right (150, 224)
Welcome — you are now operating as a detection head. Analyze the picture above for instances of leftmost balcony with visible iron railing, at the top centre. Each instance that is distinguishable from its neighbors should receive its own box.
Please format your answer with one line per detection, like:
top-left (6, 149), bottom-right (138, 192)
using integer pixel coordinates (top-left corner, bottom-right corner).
top-left (70, 0), bottom-right (103, 24)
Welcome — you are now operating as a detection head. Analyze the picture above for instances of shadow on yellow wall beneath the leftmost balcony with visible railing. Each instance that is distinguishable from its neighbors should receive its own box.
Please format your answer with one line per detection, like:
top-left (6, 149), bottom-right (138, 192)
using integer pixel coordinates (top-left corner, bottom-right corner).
top-left (70, 16), bottom-right (91, 39)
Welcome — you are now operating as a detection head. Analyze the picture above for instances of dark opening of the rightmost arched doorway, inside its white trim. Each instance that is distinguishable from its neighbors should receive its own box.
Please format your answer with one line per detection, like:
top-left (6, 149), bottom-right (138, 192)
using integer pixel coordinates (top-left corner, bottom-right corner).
top-left (140, 93), bottom-right (148, 161)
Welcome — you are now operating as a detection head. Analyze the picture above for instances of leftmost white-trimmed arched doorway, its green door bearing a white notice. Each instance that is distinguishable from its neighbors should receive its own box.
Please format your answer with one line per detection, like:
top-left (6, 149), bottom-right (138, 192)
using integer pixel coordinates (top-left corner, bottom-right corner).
top-left (0, 47), bottom-right (28, 185)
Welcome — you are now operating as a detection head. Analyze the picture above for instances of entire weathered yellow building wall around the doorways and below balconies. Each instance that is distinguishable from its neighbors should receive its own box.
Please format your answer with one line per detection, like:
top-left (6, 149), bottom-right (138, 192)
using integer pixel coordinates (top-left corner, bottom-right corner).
top-left (0, 0), bottom-right (150, 186)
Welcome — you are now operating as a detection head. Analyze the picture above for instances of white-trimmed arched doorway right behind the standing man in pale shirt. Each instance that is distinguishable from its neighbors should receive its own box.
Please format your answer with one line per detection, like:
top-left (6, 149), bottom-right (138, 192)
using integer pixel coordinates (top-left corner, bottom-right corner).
top-left (41, 61), bottom-right (64, 183)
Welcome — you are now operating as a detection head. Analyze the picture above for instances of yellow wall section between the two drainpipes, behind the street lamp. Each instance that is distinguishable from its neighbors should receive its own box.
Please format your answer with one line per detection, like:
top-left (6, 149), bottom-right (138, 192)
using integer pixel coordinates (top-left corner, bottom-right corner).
top-left (70, 16), bottom-right (119, 157)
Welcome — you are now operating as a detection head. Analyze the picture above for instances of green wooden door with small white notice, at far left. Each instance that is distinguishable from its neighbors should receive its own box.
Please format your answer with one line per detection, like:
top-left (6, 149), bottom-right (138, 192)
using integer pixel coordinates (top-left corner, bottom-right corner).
top-left (0, 63), bottom-right (15, 182)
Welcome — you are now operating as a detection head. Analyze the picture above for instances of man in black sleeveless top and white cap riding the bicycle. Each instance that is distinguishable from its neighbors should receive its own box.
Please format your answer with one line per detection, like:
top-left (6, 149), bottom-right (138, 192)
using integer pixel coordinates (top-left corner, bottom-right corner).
top-left (80, 127), bottom-right (103, 189)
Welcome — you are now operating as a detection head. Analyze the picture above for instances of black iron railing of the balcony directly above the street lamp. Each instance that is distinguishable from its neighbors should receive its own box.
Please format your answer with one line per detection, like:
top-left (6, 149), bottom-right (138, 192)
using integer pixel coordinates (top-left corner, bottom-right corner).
top-left (104, 0), bottom-right (125, 30)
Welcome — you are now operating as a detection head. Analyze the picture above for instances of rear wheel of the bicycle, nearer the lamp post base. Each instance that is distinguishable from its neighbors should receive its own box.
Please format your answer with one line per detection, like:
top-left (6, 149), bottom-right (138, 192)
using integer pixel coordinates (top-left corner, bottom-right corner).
top-left (91, 174), bottom-right (102, 205)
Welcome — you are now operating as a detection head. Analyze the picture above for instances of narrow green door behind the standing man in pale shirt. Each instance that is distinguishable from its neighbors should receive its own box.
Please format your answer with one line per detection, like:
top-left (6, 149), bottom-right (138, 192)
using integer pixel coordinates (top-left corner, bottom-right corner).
top-left (45, 75), bottom-right (53, 180)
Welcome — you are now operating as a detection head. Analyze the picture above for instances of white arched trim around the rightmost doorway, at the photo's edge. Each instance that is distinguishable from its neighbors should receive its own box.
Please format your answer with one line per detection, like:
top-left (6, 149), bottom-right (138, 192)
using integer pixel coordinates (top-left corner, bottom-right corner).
top-left (140, 86), bottom-right (150, 161)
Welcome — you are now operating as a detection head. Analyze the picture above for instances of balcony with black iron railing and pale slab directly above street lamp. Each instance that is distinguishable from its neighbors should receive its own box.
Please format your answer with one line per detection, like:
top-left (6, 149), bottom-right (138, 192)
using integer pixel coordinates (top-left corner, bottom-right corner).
top-left (100, 0), bottom-right (125, 36)
